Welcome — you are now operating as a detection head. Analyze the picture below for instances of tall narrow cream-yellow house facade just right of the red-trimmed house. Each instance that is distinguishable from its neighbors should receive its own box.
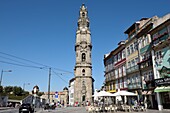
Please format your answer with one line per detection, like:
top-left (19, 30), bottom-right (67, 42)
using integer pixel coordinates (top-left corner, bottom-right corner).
top-left (124, 20), bottom-right (143, 100)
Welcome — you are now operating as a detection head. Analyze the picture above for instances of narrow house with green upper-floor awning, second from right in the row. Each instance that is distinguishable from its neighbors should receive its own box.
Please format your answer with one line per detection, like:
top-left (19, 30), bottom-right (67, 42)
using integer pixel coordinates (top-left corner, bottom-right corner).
top-left (136, 16), bottom-right (158, 108)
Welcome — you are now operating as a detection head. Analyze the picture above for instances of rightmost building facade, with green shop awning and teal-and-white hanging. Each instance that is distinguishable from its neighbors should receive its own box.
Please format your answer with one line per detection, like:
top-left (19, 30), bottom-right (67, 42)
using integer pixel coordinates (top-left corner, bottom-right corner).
top-left (150, 14), bottom-right (170, 110)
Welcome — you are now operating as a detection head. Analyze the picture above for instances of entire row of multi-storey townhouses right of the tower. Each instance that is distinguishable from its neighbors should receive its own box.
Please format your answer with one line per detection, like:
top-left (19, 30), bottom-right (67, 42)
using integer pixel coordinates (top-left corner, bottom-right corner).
top-left (104, 14), bottom-right (170, 110)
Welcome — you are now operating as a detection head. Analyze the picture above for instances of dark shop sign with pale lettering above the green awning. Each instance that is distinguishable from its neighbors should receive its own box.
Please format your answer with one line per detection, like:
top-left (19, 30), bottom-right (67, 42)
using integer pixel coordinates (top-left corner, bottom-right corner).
top-left (155, 77), bottom-right (170, 86)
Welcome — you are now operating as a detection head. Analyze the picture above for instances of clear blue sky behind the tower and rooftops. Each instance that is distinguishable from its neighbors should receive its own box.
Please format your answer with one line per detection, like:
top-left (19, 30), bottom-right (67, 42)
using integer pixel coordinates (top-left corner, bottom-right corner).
top-left (0, 0), bottom-right (170, 91)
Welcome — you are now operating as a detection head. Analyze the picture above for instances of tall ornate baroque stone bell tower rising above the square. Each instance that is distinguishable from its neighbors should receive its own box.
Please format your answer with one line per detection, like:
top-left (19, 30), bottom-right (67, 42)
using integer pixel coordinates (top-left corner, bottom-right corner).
top-left (74, 4), bottom-right (94, 103)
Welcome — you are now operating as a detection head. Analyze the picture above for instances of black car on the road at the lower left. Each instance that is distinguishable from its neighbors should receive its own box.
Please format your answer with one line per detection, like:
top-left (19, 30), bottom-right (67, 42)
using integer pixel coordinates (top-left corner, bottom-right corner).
top-left (19, 103), bottom-right (34, 113)
